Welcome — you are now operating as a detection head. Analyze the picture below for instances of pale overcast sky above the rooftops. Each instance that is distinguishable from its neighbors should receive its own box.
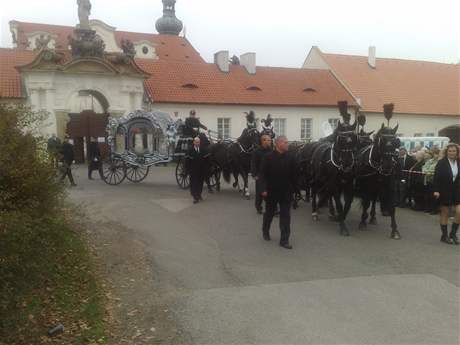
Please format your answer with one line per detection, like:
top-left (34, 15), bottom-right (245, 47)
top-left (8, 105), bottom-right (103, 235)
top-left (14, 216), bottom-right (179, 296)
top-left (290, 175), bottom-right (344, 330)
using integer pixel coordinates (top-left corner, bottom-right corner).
top-left (0, 0), bottom-right (460, 67)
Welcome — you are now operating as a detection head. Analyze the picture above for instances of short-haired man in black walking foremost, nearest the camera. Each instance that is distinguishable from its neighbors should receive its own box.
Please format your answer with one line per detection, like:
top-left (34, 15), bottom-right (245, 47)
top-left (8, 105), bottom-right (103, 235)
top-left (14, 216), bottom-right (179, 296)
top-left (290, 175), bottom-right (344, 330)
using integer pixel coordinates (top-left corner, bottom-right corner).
top-left (260, 136), bottom-right (297, 249)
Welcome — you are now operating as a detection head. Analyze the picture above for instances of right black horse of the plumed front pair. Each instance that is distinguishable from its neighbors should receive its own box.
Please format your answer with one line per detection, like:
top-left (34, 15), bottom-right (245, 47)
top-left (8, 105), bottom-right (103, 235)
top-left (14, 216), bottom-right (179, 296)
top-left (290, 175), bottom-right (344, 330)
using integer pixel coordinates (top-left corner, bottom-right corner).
top-left (356, 124), bottom-right (401, 239)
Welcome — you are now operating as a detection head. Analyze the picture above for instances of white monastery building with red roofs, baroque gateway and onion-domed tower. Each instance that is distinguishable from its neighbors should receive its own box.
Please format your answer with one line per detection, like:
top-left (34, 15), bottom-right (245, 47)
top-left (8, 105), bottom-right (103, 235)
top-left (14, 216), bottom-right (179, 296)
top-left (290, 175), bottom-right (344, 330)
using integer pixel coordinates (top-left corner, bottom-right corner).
top-left (0, 0), bottom-right (460, 153)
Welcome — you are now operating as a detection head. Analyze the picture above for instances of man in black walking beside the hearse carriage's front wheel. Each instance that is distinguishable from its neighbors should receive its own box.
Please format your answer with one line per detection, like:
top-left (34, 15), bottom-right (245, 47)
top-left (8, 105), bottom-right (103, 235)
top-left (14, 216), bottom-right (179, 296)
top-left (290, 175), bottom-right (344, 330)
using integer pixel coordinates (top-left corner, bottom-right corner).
top-left (187, 137), bottom-right (210, 204)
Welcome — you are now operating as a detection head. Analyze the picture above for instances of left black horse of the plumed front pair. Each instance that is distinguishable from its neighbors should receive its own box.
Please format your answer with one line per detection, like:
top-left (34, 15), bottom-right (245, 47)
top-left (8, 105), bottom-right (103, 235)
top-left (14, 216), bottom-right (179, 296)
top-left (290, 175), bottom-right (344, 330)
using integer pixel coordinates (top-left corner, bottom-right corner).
top-left (306, 122), bottom-right (357, 236)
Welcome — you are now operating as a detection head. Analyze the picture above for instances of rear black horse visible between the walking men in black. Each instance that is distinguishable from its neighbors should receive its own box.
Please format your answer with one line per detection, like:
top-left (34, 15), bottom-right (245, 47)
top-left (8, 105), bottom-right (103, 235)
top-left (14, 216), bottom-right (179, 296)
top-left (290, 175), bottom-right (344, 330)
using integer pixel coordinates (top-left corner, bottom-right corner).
top-left (210, 128), bottom-right (260, 199)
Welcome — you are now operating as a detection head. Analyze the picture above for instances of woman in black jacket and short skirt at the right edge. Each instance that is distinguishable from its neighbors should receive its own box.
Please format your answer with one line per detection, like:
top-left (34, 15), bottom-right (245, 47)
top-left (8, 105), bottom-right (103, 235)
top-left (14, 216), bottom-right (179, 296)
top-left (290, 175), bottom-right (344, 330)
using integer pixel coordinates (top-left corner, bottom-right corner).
top-left (433, 144), bottom-right (460, 245)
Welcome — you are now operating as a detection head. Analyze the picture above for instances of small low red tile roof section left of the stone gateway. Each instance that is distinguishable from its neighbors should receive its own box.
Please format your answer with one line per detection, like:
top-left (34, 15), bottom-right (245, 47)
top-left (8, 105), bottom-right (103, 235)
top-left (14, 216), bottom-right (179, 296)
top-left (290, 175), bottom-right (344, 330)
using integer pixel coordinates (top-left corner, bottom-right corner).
top-left (0, 48), bottom-right (35, 98)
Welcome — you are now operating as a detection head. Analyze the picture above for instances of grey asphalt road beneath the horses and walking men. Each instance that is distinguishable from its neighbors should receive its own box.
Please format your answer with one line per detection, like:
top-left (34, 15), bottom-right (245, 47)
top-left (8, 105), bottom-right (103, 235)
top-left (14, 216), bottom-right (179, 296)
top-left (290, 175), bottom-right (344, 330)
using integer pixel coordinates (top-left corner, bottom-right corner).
top-left (71, 167), bottom-right (460, 344)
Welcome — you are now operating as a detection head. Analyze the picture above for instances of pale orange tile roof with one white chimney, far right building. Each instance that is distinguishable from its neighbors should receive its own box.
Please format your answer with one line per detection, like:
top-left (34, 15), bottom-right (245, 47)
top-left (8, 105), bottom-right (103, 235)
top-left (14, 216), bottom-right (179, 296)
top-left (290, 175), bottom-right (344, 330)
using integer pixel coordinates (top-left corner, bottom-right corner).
top-left (313, 48), bottom-right (460, 115)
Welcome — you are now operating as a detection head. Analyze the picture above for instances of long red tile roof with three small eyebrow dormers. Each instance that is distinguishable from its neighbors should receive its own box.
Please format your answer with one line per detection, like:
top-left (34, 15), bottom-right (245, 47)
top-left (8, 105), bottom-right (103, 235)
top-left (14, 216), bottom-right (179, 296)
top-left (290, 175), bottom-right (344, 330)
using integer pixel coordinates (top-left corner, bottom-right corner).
top-left (137, 60), bottom-right (353, 106)
